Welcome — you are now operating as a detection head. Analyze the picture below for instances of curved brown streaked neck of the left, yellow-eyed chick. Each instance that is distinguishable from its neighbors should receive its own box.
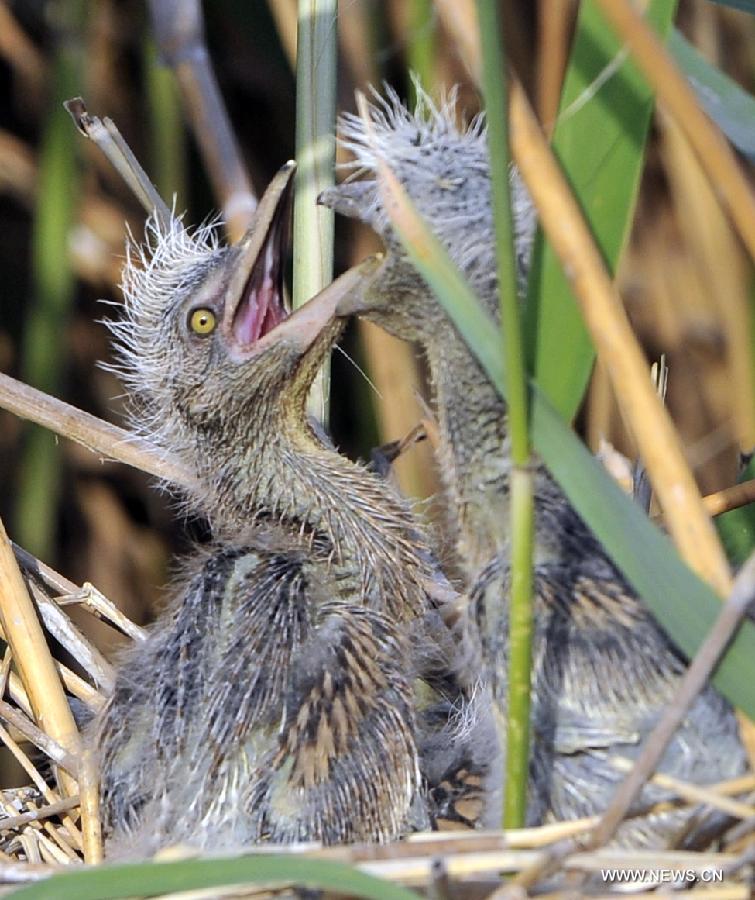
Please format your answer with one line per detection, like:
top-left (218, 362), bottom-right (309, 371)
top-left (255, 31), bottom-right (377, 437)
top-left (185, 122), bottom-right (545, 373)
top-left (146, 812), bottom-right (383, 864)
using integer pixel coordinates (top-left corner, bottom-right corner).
top-left (196, 395), bottom-right (442, 620)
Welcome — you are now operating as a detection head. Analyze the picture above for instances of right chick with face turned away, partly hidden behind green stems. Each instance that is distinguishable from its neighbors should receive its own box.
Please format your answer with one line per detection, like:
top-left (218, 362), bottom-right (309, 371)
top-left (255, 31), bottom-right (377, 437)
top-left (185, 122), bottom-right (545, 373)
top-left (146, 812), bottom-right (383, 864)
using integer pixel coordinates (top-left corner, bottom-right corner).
top-left (320, 93), bottom-right (745, 846)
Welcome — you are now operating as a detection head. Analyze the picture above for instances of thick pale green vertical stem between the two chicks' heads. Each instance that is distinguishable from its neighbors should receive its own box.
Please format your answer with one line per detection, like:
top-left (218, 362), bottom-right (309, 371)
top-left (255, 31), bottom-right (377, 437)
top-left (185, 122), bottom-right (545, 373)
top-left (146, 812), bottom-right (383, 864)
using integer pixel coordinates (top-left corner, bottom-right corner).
top-left (293, 0), bottom-right (338, 421)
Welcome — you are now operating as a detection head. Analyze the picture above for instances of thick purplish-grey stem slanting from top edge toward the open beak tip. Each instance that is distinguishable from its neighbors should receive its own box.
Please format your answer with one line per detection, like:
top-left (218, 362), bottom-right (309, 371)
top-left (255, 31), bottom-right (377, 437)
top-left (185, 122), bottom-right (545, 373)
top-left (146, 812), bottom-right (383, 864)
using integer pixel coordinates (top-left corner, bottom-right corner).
top-left (149, 0), bottom-right (257, 242)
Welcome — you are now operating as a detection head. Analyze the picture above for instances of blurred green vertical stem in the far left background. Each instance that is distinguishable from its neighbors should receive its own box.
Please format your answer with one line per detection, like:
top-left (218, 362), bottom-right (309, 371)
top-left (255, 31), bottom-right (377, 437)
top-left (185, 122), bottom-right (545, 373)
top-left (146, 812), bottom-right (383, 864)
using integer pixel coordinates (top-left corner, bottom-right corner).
top-left (15, 4), bottom-right (80, 559)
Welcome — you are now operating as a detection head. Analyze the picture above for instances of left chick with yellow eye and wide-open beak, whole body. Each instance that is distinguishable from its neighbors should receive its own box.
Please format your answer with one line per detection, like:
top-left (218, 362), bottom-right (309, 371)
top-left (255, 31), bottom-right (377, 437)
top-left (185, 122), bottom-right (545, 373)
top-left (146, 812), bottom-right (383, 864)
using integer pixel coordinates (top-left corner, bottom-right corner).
top-left (100, 164), bottom-right (500, 857)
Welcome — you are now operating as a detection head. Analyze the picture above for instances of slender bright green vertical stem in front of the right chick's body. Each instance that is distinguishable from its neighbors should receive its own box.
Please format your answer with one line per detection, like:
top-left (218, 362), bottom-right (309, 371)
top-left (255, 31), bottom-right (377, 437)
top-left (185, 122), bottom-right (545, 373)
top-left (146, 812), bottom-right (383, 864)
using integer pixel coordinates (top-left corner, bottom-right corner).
top-left (477, 0), bottom-right (534, 828)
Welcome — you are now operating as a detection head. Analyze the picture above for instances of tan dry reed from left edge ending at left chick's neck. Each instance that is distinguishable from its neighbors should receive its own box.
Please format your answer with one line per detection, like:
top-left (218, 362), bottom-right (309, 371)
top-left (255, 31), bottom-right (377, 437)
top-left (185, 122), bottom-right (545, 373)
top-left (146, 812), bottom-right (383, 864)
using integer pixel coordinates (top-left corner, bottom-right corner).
top-left (0, 373), bottom-right (194, 489)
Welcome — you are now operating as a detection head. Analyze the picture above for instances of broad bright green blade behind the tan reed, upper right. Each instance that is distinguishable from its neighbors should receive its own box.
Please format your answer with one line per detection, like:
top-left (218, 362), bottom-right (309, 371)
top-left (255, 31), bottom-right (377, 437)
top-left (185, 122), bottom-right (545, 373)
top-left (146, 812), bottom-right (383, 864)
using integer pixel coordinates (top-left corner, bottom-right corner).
top-left (525, 0), bottom-right (676, 421)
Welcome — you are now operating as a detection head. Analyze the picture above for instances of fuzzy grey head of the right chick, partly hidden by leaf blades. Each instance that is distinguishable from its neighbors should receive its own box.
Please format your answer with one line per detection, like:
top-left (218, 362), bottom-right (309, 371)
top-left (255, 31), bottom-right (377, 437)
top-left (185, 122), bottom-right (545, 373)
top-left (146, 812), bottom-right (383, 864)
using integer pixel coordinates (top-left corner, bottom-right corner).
top-left (319, 85), bottom-right (534, 343)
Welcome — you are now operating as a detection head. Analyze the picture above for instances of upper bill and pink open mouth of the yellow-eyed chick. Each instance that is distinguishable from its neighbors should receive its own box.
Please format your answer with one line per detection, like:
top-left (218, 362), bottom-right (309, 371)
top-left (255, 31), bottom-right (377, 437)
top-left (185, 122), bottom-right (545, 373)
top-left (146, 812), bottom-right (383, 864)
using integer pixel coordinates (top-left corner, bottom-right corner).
top-left (226, 163), bottom-right (294, 351)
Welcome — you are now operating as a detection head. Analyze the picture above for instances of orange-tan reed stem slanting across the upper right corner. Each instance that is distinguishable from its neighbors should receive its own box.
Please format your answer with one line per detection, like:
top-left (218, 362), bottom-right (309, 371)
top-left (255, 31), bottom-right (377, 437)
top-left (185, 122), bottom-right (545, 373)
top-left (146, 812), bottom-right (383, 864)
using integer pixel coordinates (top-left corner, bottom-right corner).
top-left (598, 0), bottom-right (755, 260)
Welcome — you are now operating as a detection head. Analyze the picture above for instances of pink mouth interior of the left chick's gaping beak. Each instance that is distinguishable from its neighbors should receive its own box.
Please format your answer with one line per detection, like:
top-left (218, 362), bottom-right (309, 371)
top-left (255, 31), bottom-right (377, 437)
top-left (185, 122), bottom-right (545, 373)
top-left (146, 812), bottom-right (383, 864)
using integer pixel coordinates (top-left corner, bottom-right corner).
top-left (231, 217), bottom-right (288, 347)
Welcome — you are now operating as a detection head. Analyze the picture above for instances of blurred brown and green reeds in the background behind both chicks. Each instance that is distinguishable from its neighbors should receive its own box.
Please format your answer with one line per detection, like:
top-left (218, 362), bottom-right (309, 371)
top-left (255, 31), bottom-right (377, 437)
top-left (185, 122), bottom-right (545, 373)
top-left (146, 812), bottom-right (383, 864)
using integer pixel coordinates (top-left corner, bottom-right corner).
top-left (0, 0), bottom-right (755, 621)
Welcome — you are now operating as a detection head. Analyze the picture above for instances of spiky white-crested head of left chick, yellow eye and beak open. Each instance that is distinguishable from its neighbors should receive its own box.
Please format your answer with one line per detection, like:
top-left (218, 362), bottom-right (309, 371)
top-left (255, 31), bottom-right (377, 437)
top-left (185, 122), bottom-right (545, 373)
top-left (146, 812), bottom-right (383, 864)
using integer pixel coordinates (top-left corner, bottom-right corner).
top-left (111, 163), bottom-right (340, 468)
